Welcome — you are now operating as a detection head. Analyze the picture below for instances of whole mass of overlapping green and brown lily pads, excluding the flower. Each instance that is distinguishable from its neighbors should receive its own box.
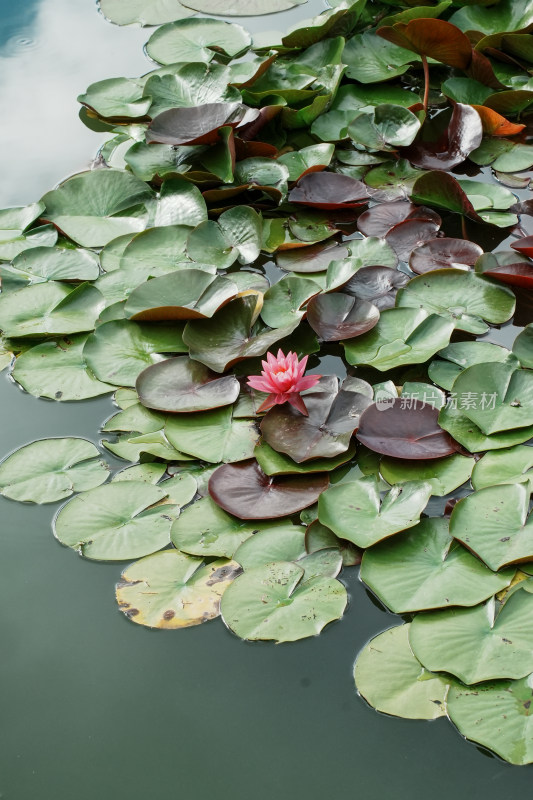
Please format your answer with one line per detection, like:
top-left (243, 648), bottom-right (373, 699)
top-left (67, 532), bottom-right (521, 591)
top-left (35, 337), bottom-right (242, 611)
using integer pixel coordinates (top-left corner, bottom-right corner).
top-left (0, 0), bottom-right (533, 764)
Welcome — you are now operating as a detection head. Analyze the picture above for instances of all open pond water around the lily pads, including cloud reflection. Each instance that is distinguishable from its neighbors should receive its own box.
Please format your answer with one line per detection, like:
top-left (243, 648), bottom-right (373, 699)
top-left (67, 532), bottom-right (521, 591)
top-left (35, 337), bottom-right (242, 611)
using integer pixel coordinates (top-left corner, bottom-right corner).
top-left (0, 0), bottom-right (532, 800)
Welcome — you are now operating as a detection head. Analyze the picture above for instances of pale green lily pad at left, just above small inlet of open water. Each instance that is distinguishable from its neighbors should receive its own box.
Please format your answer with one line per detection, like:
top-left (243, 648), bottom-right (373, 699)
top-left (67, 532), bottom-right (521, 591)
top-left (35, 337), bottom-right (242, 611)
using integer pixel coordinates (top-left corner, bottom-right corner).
top-left (11, 334), bottom-right (114, 400)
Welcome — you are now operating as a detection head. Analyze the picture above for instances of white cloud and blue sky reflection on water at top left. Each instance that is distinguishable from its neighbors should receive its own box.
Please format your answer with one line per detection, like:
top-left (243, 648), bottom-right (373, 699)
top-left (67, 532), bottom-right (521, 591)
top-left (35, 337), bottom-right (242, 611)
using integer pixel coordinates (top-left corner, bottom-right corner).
top-left (0, 0), bottom-right (150, 207)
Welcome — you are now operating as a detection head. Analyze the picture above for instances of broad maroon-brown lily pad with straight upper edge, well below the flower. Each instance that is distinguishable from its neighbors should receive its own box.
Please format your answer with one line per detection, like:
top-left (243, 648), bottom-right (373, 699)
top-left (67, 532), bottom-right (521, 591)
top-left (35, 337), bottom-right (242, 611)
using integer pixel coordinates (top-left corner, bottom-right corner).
top-left (209, 460), bottom-right (329, 519)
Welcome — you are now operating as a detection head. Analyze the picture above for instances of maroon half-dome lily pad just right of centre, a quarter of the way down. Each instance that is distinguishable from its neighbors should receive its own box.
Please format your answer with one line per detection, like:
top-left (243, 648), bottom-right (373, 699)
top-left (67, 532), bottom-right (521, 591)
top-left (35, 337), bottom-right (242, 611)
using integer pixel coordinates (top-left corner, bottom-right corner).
top-left (289, 172), bottom-right (370, 210)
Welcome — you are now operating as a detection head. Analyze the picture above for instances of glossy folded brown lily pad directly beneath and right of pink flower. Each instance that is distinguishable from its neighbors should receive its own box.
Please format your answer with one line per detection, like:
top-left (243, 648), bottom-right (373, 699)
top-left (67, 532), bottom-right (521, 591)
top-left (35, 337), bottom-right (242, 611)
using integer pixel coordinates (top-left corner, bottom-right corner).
top-left (261, 375), bottom-right (372, 464)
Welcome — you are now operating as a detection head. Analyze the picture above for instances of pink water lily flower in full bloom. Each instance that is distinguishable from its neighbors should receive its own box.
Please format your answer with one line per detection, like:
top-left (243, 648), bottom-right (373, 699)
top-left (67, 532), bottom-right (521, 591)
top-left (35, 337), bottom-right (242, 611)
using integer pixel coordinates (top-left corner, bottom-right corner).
top-left (248, 350), bottom-right (322, 417)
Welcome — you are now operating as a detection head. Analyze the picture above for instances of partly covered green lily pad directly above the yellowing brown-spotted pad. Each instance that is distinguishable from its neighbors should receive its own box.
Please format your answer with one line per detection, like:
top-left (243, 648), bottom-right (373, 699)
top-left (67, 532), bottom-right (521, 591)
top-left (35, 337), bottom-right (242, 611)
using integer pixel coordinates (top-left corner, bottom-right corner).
top-left (171, 497), bottom-right (302, 566)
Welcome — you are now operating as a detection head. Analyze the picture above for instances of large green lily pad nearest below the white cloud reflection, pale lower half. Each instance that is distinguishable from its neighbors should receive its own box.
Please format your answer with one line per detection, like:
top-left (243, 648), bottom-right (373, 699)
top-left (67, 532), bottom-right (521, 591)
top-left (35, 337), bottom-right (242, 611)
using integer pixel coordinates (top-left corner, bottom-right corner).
top-left (42, 169), bottom-right (153, 247)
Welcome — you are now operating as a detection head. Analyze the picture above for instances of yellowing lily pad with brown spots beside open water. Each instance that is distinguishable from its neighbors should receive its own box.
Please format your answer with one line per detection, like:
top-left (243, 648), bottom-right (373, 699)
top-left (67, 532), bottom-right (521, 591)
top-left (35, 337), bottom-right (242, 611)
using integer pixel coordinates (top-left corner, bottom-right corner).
top-left (116, 550), bottom-right (241, 630)
